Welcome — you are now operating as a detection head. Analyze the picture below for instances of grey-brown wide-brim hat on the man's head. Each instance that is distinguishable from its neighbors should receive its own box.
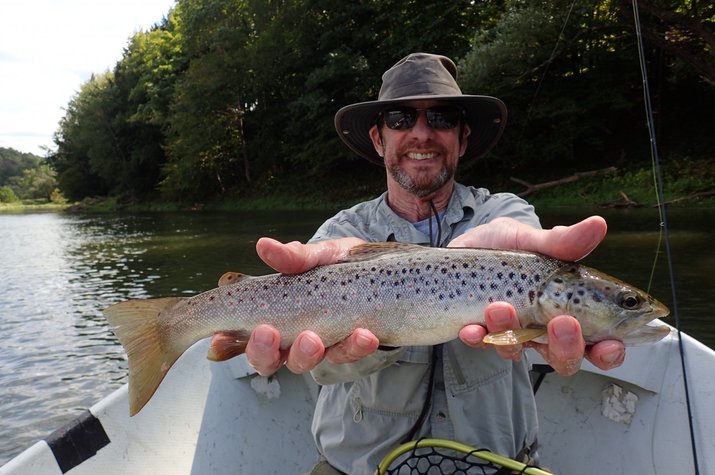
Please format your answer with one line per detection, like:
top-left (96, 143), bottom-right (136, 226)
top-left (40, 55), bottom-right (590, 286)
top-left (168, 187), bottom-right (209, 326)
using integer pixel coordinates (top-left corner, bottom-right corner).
top-left (335, 53), bottom-right (506, 166)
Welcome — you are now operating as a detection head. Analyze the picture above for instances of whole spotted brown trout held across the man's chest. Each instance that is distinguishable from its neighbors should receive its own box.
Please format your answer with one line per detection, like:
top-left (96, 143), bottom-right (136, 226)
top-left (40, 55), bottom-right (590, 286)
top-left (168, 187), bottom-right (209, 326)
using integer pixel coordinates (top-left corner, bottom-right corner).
top-left (104, 243), bottom-right (670, 416)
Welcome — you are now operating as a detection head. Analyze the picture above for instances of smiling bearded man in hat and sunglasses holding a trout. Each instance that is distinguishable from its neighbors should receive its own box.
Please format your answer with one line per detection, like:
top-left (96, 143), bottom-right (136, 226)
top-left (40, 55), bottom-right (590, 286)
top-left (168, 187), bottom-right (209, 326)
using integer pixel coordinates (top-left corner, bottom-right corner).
top-left (214, 53), bottom-right (625, 474)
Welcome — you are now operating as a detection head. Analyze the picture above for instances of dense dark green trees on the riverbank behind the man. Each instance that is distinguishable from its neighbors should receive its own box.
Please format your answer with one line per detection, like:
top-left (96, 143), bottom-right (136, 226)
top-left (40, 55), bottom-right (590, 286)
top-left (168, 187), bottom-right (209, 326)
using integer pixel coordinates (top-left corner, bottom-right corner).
top-left (50, 0), bottom-right (715, 201)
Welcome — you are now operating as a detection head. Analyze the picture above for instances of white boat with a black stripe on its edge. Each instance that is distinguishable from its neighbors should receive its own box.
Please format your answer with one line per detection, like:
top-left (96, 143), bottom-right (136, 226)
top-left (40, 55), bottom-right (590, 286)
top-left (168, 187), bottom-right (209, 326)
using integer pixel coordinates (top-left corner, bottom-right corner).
top-left (0, 323), bottom-right (715, 475)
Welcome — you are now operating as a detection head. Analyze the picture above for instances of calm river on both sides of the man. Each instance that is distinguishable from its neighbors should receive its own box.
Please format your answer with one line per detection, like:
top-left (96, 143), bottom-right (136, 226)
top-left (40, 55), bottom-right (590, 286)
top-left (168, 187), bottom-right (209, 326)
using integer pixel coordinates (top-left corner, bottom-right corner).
top-left (0, 209), bottom-right (715, 465)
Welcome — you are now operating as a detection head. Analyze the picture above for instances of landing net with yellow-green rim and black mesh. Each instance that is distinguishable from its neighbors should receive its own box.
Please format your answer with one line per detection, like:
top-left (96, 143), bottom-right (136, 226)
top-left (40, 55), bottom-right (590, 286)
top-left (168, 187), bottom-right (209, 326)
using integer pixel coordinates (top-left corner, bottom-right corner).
top-left (375, 439), bottom-right (553, 475)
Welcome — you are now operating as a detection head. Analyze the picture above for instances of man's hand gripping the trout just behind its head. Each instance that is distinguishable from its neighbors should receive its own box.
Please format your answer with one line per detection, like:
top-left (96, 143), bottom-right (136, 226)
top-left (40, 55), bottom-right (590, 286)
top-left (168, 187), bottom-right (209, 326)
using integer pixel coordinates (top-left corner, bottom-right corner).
top-left (449, 216), bottom-right (625, 375)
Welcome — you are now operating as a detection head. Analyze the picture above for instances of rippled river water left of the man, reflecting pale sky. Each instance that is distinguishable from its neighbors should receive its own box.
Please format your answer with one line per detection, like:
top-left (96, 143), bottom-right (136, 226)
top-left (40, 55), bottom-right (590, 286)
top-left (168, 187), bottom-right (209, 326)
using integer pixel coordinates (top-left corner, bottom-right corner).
top-left (0, 213), bottom-right (332, 464)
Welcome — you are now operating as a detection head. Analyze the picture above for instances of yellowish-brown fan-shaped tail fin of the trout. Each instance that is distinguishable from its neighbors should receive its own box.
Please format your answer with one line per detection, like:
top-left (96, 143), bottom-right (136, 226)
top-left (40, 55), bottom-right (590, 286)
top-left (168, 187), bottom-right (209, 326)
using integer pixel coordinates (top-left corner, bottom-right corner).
top-left (104, 297), bottom-right (186, 416)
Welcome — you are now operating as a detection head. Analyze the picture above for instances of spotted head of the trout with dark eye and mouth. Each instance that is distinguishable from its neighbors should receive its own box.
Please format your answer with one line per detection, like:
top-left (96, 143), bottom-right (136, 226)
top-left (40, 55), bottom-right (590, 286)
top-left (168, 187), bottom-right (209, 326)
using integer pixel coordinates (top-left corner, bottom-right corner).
top-left (537, 264), bottom-right (670, 344)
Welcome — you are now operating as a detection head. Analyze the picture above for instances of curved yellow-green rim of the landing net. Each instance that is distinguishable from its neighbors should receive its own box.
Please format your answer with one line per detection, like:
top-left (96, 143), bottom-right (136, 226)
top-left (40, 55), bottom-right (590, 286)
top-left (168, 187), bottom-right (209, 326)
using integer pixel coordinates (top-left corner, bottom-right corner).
top-left (375, 439), bottom-right (553, 475)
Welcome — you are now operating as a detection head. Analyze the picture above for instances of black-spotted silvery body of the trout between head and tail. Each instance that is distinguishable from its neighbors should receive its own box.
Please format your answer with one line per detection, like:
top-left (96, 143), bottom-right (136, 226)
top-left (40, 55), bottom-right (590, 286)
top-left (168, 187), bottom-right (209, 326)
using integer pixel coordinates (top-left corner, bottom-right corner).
top-left (169, 244), bottom-right (563, 347)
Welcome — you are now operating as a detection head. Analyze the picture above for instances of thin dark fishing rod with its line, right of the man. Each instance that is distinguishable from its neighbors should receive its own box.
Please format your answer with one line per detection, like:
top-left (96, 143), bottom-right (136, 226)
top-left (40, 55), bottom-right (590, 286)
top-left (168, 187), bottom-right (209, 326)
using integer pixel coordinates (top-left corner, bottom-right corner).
top-left (632, 0), bottom-right (700, 475)
